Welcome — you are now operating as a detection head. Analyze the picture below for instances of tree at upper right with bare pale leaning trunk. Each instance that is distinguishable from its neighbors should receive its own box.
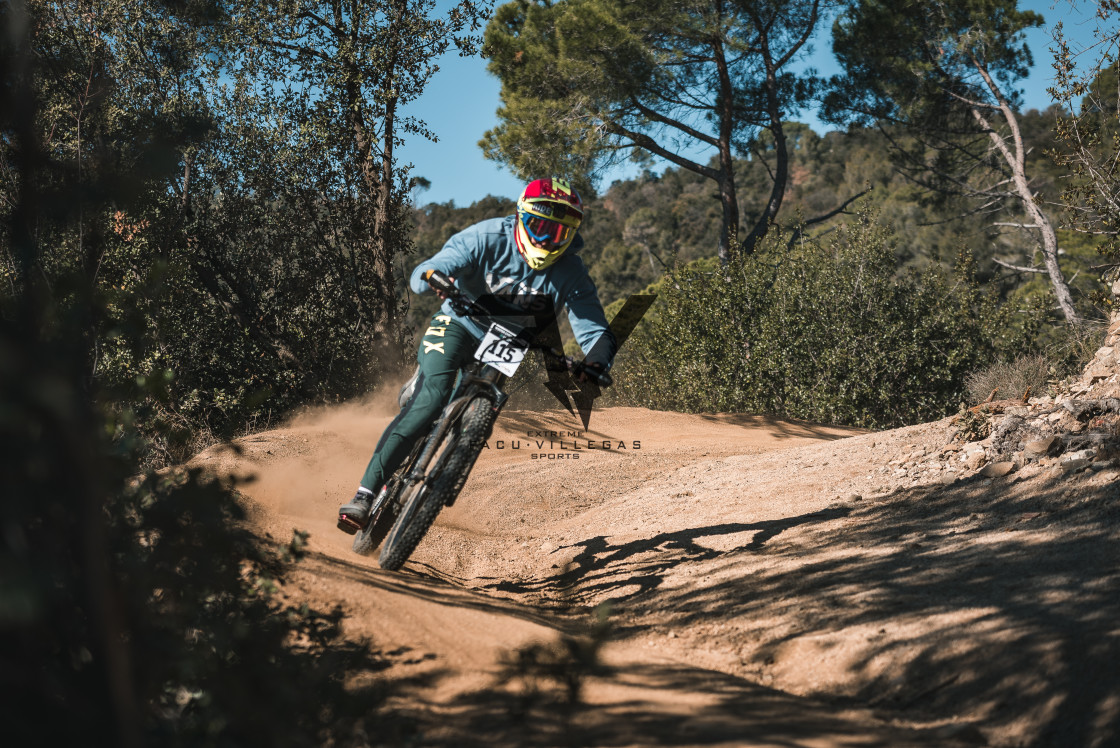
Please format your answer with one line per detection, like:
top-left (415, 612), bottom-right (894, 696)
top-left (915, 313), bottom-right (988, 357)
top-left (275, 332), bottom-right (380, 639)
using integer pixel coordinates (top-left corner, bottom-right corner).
top-left (825, 0), bottom-right (1079, 324)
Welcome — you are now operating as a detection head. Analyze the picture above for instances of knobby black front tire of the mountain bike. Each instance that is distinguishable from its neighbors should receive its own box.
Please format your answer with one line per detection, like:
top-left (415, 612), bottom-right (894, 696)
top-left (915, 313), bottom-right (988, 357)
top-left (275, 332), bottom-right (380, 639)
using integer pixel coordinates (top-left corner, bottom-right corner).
top-left (379, 398), bottom-right (495, 571)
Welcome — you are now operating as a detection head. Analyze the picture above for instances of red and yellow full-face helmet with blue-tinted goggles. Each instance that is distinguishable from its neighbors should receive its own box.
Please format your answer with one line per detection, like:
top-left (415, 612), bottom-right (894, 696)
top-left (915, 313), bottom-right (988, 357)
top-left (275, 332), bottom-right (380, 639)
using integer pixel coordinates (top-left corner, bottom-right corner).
top-left (514, 177), bottom-right (584, 270)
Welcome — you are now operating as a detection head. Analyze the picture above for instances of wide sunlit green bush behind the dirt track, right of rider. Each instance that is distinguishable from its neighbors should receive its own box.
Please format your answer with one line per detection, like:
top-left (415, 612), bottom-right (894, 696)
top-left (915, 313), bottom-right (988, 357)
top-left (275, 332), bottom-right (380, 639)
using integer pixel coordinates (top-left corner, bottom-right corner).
top-left (613, 215), bottom-right (1043, 428)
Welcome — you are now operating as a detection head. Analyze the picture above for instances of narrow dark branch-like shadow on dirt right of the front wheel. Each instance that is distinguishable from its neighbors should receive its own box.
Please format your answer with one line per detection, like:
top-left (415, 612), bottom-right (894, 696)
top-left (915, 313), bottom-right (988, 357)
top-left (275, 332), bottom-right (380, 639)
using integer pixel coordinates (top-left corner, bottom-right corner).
top-left (483, 507), bottom-right (851, 599)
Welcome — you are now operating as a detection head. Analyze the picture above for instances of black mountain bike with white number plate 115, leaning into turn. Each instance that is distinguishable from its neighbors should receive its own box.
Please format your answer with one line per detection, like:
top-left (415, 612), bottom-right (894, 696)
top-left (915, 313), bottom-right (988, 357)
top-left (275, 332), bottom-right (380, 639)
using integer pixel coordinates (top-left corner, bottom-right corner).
top-left (353, 271), bottom-right (612, 571)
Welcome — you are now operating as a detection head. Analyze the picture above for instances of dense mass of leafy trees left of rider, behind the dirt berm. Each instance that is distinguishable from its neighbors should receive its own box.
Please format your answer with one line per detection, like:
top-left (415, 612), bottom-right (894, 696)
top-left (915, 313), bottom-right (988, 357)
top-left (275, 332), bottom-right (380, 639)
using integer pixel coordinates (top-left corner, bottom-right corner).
top-left (0, 0), bottom-right (495, 462)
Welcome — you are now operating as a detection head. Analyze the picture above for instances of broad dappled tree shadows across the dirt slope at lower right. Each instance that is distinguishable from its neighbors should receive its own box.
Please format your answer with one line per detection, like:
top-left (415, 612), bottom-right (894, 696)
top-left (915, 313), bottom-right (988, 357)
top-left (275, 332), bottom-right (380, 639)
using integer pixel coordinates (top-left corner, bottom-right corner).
top-left (470, 476), bottom-right (1120, 747)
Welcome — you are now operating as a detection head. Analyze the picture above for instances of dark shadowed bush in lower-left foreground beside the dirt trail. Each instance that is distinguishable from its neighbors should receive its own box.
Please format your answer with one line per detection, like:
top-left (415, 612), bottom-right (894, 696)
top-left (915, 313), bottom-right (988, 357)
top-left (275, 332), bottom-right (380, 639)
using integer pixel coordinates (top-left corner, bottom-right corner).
top-left (113, 473), bottom-right (383, 746)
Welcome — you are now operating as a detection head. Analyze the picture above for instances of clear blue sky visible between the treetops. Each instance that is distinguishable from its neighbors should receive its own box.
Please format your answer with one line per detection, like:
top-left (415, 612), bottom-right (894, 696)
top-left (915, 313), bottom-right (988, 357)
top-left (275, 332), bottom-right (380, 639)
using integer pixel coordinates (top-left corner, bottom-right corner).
top-left (398, 0), bottom-right (1095, 206)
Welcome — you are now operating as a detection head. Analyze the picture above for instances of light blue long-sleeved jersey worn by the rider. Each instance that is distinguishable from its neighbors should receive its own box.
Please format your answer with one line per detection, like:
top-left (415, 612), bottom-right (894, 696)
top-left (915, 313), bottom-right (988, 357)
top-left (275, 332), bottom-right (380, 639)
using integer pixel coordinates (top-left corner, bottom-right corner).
top-left (410, 216), bottom-right (618, 367)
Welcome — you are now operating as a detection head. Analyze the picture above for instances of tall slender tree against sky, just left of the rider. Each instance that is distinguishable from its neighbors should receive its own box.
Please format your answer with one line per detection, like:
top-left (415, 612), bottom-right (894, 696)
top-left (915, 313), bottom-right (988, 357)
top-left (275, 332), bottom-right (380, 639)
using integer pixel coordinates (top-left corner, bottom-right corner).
top-left (220, 0), bottom-right (486, 339)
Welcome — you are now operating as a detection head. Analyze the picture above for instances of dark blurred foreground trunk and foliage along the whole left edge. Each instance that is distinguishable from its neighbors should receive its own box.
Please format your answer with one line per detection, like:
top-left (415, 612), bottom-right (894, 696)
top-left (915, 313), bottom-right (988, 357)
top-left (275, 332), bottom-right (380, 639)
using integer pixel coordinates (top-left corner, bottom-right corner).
top-left (0, 0), bottom-right (382, 748)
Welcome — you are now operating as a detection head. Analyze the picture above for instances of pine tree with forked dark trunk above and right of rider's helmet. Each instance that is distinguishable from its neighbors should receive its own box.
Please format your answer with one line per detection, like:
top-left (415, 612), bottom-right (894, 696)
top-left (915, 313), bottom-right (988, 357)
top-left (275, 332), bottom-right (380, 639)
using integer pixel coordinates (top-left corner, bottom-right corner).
top-left (482, 0), bottom-right (831, 263)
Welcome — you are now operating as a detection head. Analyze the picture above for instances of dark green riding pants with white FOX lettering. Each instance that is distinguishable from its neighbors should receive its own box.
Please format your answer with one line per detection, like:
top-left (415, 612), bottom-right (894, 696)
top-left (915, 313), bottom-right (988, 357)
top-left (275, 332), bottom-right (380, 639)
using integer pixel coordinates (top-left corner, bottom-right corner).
top-left (362, 311), bottom-right (478, 494)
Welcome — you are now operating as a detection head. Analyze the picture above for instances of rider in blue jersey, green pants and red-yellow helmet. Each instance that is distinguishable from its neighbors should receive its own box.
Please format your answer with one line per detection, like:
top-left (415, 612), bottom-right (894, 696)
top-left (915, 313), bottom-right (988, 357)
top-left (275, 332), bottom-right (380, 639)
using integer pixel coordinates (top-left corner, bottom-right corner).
top-left (338, 177), bottom-right (617, 533)
